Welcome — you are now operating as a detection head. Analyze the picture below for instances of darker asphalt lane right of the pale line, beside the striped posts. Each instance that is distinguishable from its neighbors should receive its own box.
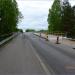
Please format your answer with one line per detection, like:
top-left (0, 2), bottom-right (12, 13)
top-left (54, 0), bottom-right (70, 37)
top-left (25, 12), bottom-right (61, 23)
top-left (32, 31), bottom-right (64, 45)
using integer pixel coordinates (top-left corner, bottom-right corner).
top-left (25, 33), bottom-right (75, 75)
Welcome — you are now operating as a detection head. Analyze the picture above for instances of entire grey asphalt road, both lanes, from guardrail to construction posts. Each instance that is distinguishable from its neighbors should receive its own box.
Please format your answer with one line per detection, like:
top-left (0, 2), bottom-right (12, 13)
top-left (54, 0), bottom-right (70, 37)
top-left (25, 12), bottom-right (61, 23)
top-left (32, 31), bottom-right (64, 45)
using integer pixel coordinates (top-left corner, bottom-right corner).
top-left (0, 33), bottom-right (75, 75)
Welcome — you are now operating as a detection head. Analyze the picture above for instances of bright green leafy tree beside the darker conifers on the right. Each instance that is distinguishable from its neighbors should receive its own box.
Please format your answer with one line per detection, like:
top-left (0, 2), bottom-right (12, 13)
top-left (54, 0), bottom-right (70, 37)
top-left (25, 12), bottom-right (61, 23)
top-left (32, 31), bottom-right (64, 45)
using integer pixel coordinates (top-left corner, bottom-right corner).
top-left (48, 0), bottom-right (61, 32)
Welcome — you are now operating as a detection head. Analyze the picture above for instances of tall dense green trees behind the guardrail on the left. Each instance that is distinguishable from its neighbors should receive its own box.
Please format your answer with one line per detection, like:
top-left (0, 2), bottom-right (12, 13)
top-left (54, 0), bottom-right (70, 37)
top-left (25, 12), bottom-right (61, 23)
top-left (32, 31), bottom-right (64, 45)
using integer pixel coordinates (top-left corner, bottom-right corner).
top-left (0, 0), bottom-right (20, 35)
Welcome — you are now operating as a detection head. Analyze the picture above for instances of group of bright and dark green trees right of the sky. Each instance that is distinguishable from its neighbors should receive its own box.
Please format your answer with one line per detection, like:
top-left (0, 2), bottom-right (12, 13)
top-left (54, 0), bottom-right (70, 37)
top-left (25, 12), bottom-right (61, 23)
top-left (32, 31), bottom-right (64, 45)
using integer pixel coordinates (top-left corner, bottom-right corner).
top-left (48, 0), bottom-right (75, 38)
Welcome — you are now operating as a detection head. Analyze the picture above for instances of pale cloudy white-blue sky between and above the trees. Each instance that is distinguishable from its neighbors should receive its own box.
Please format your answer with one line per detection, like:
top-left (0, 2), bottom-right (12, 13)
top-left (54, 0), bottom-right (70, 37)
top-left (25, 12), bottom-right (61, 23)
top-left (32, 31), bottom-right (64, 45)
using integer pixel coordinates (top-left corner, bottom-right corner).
top-left (17, 0), bottom-right (75, 31)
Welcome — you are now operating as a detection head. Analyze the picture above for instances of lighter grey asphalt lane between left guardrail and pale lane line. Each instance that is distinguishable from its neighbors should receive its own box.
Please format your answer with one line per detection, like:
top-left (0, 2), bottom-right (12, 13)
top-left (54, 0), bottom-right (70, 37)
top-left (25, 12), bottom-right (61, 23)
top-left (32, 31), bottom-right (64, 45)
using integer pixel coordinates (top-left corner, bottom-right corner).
top-left (0, 34), bottom-right (47, 75)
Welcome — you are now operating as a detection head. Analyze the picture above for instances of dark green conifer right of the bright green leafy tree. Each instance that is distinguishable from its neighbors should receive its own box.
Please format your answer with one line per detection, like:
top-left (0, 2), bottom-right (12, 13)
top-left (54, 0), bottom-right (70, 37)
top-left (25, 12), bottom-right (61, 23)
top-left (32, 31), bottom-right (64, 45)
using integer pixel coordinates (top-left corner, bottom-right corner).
top-left (62, 2), bottom-right (74, 37)
